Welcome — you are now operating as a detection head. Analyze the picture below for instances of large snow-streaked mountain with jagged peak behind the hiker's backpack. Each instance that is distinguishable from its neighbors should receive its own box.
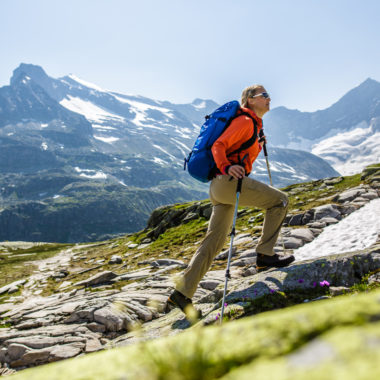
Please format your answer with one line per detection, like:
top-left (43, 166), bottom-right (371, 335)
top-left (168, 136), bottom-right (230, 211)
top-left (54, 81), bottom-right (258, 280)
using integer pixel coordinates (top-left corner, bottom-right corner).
top-left (0, 64), bottom-right (338, 241)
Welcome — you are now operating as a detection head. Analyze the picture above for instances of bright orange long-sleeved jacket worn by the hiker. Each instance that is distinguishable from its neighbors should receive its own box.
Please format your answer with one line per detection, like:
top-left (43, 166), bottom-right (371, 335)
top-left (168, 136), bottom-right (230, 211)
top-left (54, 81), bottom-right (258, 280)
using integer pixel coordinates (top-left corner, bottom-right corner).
top-left (211, 108), bottom-right (263, 175)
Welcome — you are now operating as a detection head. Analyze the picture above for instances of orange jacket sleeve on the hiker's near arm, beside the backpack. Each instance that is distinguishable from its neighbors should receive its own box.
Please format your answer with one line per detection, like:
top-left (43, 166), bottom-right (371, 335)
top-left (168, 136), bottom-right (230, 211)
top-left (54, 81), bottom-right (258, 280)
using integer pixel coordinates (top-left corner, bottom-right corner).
top-left (211, 117), bottom-right (252, 174)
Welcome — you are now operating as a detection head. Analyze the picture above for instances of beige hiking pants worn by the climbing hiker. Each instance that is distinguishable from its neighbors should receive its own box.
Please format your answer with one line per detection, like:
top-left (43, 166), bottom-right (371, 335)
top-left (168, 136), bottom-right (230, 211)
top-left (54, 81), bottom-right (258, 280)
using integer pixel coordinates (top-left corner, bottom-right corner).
top-left (176, 175), bottom-right (288, 298)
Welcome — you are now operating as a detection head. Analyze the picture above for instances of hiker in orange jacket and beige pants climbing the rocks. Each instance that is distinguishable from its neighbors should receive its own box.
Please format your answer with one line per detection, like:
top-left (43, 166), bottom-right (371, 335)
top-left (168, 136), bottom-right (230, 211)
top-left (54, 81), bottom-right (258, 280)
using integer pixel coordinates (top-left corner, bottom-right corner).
top-left (167, 85), bottom-right (294, 311)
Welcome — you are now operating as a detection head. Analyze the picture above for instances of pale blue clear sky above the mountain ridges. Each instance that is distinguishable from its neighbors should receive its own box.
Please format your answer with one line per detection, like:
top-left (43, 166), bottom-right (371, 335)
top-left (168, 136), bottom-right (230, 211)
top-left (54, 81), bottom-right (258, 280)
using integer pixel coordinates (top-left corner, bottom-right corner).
top-left (0, 0), bottom-right (380, 111)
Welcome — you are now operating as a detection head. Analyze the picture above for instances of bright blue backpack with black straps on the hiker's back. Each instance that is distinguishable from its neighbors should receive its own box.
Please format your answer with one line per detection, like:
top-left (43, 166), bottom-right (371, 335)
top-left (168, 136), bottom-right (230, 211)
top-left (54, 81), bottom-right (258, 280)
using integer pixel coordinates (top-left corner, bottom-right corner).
top-left (184, 100), bottom-right (257, 182)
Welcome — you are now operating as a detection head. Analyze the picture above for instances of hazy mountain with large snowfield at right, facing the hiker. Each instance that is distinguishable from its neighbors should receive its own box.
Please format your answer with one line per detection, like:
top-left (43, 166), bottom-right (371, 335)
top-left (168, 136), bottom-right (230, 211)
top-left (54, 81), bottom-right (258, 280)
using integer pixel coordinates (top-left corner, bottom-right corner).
top-left (265, 79), bottom-right (380, 175)
